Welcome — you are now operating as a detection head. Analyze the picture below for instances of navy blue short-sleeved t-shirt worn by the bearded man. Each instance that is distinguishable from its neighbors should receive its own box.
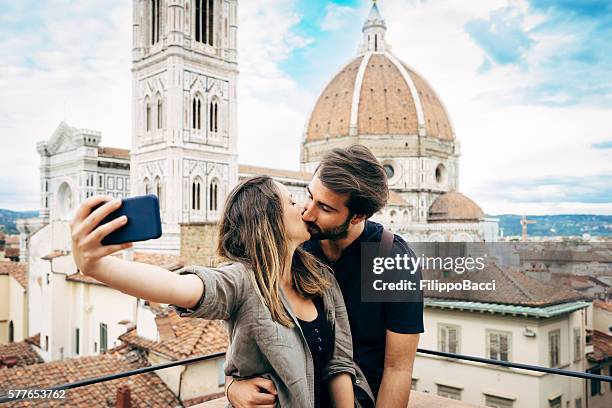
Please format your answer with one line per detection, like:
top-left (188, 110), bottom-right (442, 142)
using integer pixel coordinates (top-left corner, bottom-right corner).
top-left (304, 221), bottom-right (424, 396)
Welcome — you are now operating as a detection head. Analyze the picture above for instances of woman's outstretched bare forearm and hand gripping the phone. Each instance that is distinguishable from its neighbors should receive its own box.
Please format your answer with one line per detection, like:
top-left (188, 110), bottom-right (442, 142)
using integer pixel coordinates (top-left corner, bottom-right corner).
top-left (70, 196), bottom-right (204, 308)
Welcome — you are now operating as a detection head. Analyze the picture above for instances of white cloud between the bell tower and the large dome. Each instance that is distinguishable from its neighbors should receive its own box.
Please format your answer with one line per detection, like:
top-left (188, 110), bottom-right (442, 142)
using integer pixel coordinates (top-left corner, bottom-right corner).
top-left (238, 0), bottom-right (313, 170)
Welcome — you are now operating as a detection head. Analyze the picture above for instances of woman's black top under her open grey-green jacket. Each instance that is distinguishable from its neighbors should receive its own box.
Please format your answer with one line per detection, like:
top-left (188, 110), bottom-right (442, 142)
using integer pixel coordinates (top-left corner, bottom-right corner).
top-left (298, 297), bottom-right (334, 408)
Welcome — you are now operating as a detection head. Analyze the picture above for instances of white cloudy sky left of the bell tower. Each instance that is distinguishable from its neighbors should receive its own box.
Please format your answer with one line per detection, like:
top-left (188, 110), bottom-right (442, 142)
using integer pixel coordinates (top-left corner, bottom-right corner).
top-left (0, 0), bottom-right (131, 210)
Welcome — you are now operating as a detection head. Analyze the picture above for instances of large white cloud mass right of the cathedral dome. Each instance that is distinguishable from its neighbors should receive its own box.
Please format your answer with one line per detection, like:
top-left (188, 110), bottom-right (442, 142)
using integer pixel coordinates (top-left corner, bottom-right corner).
top-left (383, 0), bottom-right (612, 214)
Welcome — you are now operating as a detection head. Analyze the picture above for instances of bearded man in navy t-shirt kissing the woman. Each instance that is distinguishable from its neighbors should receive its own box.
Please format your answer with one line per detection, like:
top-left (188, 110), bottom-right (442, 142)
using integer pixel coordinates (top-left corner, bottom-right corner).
top-left (228, 145), bottom-right (424, 408)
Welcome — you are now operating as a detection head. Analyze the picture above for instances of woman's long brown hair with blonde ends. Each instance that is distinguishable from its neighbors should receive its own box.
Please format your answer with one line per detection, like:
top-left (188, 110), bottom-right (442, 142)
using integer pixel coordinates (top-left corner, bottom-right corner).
top-left (217, 176), bottom-right (330, 327)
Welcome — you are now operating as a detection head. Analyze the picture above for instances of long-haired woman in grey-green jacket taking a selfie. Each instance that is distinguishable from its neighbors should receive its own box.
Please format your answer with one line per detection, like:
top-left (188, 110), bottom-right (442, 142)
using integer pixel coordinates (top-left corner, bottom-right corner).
top-left (70, 176), bottom-right (376, 408)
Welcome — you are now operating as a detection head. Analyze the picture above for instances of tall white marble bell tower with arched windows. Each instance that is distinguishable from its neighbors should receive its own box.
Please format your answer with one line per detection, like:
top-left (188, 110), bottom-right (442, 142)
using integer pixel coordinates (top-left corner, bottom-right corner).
top-left (131, 0), bottom-right (238, 253)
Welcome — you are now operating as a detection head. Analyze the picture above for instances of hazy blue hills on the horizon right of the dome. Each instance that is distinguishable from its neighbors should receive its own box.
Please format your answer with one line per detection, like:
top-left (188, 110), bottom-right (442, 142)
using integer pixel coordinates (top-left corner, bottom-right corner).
top-left (491, 214), bottom-right (612, 237)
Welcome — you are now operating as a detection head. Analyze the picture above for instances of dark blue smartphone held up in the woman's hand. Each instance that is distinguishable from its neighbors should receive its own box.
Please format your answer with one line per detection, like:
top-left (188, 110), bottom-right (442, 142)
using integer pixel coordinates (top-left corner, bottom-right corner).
top-left (92, 194), bottom-right (162, 245)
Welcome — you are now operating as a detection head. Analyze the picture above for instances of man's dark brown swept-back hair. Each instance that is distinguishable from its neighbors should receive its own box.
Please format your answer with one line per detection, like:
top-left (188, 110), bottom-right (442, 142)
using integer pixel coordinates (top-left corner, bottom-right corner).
top-left (315, 144), bottom-right (389, 218)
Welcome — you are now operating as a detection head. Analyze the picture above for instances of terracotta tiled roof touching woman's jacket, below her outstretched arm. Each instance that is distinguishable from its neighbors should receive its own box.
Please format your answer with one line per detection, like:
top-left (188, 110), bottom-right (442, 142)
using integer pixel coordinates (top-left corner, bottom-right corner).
top-left (119, 311), bottom-right (228, 360)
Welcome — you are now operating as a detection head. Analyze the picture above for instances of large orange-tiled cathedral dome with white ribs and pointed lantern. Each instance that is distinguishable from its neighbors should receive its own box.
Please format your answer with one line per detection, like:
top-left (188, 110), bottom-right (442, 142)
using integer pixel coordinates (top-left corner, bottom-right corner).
top-left (304, 4), bottom-right (454, 143)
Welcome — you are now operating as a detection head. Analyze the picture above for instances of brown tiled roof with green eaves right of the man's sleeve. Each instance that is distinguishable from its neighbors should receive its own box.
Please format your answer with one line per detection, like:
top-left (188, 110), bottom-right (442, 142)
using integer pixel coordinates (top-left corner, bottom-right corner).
top-left (423, 263), bottom-right (586, 307)
